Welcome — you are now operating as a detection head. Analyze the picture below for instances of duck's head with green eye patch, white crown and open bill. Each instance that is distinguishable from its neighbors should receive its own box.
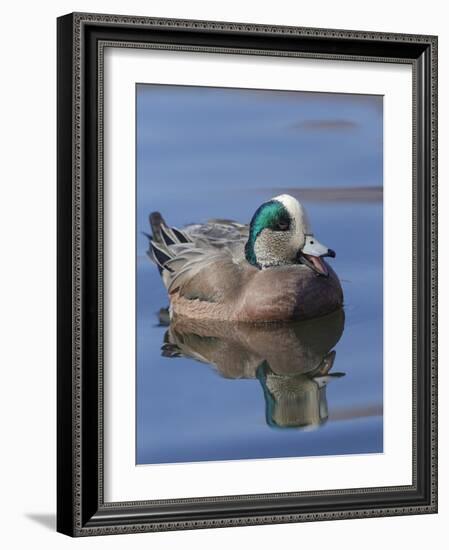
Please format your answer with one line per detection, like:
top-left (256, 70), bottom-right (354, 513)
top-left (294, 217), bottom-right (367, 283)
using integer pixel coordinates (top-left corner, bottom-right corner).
top-left (245, 195), bottom-right (335, 277)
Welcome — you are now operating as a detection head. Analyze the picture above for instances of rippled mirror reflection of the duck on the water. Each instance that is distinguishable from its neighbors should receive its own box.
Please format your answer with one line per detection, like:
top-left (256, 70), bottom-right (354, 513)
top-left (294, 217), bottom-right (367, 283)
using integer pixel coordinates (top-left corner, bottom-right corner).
top-left (160, 309), bottom-right (345, 429)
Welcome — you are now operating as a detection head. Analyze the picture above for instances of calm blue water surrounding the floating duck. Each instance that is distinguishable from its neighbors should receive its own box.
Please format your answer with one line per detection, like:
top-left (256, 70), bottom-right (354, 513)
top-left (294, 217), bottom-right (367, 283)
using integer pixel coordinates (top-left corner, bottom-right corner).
top-left (136, 86), bottom-right (383, 464)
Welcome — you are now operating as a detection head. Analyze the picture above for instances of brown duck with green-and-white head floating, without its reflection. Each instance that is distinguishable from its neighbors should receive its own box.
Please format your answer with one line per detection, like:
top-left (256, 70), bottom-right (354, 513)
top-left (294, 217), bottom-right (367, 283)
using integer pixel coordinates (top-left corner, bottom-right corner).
top-left (147, 194), bottom-right (343, 323)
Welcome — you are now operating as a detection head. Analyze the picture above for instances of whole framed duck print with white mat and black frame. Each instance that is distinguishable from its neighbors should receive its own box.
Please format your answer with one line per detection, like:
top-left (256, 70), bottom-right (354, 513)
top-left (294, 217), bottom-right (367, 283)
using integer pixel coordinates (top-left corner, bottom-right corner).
top-left (57, 13), bottom-right (437, 536)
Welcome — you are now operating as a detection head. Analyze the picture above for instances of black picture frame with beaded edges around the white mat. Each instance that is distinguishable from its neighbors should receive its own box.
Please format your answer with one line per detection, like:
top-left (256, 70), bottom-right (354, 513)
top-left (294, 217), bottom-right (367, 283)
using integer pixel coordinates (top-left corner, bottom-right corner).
top-left (57, 13), bottom-right (437, 536)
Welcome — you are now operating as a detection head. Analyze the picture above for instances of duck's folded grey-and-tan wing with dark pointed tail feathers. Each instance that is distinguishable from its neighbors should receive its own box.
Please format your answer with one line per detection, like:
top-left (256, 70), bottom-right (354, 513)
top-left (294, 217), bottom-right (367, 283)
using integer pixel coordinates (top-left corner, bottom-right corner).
top-left (148, 213), bottom-right (247, 303)
